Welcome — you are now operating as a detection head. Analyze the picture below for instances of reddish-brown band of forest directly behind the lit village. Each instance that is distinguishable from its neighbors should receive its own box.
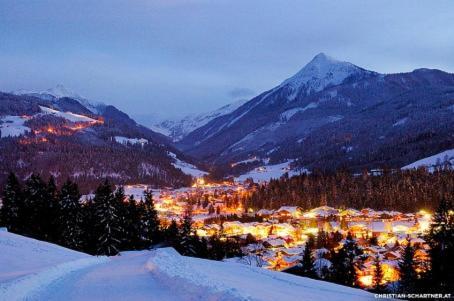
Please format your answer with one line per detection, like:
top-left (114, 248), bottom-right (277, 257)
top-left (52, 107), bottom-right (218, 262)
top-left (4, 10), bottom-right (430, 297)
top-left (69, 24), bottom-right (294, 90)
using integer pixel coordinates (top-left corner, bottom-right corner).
top-left (244, 168), bottom-right (454, 212)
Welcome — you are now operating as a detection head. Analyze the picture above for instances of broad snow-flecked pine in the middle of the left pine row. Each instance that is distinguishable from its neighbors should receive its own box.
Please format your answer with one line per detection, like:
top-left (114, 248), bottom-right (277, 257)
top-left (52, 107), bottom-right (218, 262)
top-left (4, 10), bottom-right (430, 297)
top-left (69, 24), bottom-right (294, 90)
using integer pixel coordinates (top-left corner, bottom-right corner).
top-left (93, 180), bottom-right (121, 256)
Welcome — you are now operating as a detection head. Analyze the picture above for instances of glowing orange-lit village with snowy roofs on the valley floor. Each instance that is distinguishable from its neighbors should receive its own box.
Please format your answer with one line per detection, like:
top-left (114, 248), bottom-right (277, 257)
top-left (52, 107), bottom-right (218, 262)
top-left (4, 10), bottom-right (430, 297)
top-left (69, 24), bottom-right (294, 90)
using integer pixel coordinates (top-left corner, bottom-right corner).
top-left (125, 179), bottom-right (432, 288)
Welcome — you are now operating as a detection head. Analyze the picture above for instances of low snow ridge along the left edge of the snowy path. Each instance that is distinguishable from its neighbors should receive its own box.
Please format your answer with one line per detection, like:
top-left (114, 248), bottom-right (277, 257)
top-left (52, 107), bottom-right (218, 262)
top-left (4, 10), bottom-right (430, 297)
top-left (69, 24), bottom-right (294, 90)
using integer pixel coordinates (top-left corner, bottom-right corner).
top-left (0, 256), bottom-right (109, 301)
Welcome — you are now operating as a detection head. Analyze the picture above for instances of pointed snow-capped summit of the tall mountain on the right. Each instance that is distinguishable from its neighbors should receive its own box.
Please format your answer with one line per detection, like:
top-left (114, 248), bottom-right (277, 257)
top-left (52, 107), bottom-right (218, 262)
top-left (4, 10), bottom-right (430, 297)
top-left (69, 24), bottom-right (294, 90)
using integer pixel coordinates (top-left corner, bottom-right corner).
top-left (281, 52), bottom-right (371, 94)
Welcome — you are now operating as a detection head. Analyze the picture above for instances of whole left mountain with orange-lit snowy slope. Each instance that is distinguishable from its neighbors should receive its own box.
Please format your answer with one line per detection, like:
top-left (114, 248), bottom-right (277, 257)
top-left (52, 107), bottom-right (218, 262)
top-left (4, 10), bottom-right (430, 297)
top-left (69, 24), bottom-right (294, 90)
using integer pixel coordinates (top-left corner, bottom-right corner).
top-left (0, 87), bottom-right (204, 191)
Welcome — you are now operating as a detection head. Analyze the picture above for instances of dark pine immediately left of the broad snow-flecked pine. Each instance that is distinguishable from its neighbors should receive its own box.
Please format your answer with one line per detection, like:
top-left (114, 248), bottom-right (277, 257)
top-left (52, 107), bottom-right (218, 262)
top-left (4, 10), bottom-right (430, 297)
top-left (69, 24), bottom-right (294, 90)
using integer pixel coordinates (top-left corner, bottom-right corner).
top-left (58, 179), bottom-right (83, 250)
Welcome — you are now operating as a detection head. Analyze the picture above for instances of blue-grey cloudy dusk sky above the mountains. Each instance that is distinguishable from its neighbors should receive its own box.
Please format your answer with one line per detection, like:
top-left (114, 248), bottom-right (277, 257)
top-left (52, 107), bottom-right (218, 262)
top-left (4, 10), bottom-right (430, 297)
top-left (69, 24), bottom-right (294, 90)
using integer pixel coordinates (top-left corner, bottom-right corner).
top-left (0, 0), bottom-right (454, 119)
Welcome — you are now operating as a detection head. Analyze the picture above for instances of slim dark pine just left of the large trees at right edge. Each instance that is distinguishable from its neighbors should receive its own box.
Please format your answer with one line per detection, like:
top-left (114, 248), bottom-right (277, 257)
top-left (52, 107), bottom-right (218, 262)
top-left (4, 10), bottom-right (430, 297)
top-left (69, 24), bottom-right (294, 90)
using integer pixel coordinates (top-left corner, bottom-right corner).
top-left (399, 241), bottom-right (417, 293)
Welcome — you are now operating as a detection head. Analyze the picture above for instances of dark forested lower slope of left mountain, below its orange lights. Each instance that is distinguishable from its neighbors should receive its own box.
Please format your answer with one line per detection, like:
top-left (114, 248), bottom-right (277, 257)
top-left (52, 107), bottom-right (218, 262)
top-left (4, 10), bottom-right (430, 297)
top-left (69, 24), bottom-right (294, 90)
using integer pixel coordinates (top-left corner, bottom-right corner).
top-left (0, 136), bottom-right (192, 193)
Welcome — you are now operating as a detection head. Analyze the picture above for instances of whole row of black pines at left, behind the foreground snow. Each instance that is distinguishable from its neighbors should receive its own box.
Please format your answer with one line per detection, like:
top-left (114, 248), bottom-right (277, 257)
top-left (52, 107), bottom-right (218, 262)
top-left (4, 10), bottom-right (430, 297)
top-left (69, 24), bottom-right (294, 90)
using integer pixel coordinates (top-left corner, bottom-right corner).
top-left (0, 173), bottom-right (241, 260)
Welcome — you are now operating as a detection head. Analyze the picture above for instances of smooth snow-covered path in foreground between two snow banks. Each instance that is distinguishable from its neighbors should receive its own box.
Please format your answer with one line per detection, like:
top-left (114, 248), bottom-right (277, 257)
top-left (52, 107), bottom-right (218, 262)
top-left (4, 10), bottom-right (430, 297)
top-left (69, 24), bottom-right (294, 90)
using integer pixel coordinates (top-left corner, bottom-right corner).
top-left (27, 251), bottom-right (189, 301)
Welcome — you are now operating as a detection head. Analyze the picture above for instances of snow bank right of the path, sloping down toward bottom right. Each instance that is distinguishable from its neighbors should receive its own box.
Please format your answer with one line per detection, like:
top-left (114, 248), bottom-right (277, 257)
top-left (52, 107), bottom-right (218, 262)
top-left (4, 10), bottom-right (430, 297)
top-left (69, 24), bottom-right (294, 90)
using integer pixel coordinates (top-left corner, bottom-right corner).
top-left (147, 248), bottom-right (374, 301)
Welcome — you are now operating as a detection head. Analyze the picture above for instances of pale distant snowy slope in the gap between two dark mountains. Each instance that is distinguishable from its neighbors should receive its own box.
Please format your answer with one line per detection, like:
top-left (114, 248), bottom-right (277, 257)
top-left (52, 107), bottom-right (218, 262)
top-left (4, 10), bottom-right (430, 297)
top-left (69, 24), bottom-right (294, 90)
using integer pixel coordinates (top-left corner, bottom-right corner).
top-left (150, 100), bottom-right (247, 142)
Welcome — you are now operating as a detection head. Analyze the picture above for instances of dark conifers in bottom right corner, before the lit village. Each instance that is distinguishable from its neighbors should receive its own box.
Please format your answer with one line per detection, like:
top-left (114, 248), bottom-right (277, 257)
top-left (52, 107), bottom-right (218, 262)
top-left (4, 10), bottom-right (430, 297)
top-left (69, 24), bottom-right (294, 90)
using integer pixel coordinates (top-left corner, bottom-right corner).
top-left (289, 199), bottom-right (454, 294)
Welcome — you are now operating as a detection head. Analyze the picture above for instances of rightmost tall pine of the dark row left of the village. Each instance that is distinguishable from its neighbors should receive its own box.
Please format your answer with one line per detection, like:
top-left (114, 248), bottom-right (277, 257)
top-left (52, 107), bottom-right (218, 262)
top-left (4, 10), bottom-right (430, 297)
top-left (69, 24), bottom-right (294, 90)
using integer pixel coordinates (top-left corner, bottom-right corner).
top-left (141, 190), bottom-right (161, 248)
